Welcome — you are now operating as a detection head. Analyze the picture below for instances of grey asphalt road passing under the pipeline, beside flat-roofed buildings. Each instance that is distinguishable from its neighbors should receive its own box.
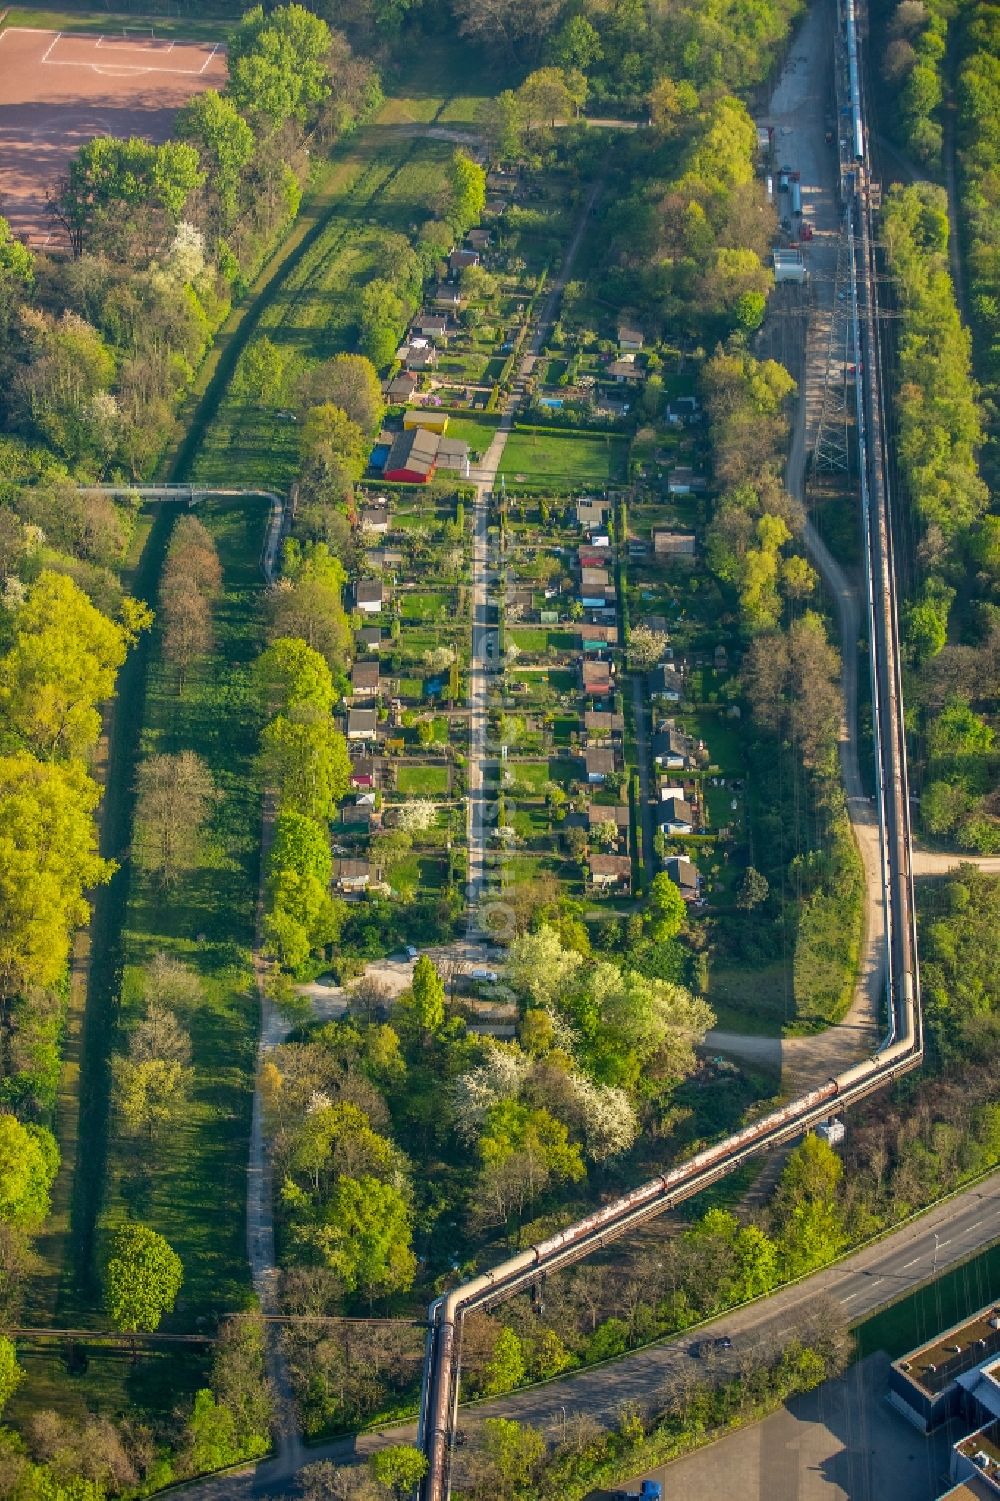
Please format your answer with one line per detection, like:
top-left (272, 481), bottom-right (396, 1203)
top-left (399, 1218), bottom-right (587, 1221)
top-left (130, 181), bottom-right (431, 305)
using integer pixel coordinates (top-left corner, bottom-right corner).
top-left (171, 1172), bottom-right (1000, 1501)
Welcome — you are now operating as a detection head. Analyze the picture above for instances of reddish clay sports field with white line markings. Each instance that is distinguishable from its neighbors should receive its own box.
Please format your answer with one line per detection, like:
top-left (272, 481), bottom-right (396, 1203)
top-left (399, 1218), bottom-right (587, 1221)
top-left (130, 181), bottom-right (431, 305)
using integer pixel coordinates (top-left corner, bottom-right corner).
top-left (0, 27), bottom-right (225, 245)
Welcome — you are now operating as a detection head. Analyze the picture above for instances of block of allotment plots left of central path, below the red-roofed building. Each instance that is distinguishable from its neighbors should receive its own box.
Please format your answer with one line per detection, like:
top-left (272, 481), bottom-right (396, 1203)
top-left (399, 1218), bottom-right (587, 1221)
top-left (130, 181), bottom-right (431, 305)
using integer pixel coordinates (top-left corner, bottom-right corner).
top-left (333, 486), bottom-right (470, 918)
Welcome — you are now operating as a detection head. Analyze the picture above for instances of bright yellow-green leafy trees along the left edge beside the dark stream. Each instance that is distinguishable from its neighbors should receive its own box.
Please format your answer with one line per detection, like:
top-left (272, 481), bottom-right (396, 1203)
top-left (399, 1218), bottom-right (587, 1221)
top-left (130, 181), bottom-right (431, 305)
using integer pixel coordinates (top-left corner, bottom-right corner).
top-left (0, 569), bottom-right (149, 1117)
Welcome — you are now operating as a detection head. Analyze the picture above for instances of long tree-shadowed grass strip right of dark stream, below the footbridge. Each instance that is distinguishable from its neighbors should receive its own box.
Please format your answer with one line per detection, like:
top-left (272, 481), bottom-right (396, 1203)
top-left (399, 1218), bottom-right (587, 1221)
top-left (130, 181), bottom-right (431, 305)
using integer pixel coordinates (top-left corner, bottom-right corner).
top-left (102, 501), bottom-right (267, 1330)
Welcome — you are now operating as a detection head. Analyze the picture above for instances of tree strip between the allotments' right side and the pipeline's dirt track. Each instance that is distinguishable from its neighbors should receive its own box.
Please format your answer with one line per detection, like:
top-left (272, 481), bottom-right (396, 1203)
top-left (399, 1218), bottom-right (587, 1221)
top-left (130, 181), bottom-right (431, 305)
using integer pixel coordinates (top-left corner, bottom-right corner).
top-left (701, 336), bottom-right (863, 1025)
